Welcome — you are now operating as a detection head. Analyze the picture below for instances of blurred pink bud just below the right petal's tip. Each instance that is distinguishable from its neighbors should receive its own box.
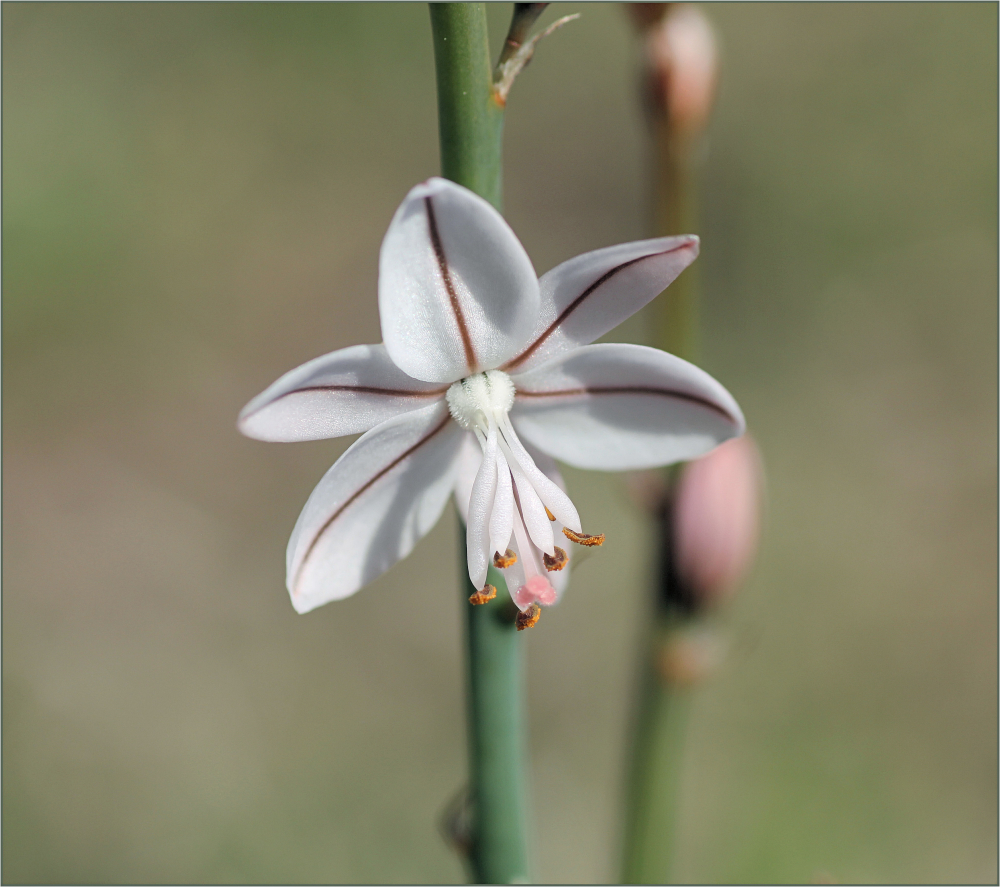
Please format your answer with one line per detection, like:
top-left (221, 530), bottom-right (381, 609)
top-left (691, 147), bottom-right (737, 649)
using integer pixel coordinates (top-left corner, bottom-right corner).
top-left (673, 435), bottom-right (763, 604)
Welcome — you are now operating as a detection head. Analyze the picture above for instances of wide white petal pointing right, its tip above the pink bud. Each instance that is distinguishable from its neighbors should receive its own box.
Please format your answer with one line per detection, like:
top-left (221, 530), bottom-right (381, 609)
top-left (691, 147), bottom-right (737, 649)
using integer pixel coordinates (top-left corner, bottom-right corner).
top-left (511, 344), bottom-right (744, 476)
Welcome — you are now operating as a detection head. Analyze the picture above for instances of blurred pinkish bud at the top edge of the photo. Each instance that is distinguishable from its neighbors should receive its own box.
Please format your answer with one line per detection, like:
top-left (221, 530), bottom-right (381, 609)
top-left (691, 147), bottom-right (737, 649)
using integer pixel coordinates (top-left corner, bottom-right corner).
top-left (646, 3), bottom-right (718, 136)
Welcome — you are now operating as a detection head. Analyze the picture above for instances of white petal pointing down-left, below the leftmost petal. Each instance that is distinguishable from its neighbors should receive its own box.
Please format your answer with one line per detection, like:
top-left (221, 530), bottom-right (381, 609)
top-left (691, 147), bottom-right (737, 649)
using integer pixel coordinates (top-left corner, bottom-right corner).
top-left (287, 403), bottom-right (462, 613)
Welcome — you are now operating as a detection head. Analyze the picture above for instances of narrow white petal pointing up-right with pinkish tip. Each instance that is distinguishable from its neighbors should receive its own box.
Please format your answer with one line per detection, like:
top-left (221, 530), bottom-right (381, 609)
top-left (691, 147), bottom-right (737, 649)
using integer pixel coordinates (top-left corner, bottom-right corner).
top-left (502, 235), bottom-right (699, 373)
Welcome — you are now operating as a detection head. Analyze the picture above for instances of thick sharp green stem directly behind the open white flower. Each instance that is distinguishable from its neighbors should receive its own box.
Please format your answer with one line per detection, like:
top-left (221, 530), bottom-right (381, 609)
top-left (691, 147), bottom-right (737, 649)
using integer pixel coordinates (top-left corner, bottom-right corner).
top-left (430, 3), bottom-right (528, 884)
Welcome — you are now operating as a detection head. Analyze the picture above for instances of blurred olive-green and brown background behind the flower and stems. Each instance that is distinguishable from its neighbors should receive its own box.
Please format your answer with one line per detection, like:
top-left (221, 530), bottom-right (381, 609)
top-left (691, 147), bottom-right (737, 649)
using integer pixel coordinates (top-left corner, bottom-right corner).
top-left (2, 3), bottom-right (998, 883)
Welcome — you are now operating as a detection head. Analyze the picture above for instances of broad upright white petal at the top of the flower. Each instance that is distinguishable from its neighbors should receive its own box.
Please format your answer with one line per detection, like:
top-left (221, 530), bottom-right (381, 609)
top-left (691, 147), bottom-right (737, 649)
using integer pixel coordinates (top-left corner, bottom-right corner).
top-left (378, 178), bottom-right (538, 382)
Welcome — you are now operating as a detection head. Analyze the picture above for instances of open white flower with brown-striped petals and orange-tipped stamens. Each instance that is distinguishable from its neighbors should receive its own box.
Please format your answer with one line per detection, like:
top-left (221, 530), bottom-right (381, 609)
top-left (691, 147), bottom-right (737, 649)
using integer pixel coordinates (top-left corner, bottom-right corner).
top-left (239, 178), bottom-right (744, 613)
